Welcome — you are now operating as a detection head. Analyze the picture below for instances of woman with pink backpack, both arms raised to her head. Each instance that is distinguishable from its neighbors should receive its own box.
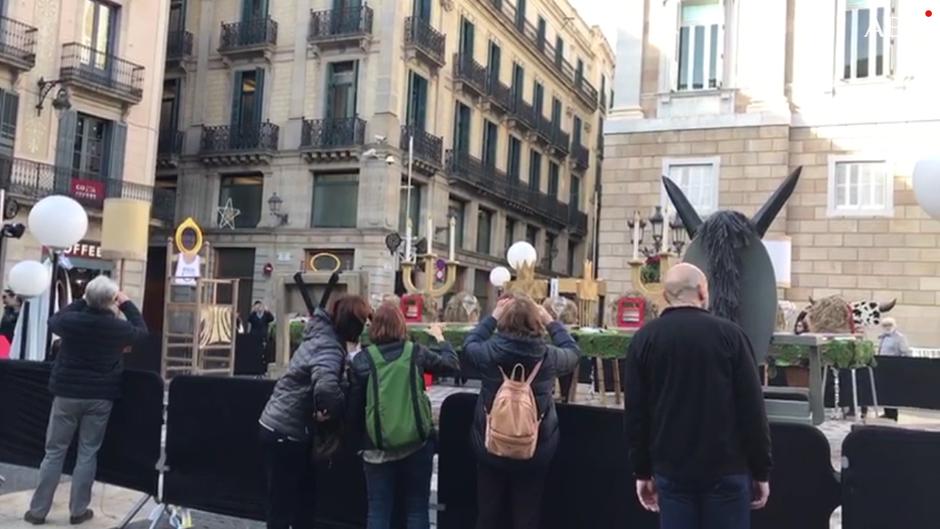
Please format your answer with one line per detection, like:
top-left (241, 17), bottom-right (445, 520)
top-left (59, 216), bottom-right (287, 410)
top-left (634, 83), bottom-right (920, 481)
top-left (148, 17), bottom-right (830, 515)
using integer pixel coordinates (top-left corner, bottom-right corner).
top-left (462, 296), bottom-right (581, 529)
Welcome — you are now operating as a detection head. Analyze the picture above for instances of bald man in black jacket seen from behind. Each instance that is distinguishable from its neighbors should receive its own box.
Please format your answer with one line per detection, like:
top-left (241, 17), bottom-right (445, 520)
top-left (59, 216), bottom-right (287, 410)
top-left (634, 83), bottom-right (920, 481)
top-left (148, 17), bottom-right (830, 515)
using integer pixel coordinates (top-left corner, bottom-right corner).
top-left (626, 264), bottom-right (772, 529)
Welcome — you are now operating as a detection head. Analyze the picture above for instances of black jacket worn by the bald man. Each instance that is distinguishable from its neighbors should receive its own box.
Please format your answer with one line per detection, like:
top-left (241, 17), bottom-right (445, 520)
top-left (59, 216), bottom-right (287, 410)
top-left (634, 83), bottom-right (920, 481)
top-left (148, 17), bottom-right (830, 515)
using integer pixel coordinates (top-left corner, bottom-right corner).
top-left (626, 307), bottom-right (771, 481)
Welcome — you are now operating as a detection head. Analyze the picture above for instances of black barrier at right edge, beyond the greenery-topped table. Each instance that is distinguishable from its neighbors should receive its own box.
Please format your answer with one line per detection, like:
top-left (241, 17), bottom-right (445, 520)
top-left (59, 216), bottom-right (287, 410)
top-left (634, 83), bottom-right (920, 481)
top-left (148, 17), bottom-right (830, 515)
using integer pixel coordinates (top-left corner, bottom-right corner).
top-left (826, 356), bottom-right (940, 410)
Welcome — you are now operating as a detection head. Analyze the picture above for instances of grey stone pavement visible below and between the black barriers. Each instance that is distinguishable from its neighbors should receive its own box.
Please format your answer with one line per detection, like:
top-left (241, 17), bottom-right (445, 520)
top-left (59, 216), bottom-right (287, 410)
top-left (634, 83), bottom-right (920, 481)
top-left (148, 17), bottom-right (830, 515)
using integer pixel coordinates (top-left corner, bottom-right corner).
top-left (0, 382), bottom-right (940, 529)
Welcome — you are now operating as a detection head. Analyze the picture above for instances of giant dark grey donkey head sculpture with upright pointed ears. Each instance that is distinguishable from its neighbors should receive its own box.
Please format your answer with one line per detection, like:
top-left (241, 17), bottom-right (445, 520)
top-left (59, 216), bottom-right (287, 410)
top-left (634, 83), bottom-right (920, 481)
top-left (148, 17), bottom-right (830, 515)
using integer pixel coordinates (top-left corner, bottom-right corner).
top-left (663, 167), bottom-right (803, 363)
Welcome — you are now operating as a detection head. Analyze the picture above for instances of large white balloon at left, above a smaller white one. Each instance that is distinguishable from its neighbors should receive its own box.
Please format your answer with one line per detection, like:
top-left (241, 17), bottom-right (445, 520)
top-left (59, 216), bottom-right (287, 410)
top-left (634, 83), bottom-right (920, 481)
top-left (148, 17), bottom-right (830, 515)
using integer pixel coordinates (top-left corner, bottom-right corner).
top-left (28, 195), bottom-right (88, 250)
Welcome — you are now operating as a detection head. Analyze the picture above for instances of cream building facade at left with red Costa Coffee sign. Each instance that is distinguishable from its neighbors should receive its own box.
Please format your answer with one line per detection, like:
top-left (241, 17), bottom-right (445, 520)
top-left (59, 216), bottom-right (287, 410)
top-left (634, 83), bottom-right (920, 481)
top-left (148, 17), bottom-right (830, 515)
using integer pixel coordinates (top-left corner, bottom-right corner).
top-left (0, 0), bottom-right (174, 300)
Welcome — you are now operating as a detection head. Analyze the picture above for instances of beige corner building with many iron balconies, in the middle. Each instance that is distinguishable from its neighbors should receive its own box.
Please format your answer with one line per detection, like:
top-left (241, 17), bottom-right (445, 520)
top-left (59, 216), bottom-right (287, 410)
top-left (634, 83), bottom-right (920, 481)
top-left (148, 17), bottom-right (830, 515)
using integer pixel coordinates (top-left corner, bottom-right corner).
top-left (157, 0), bottom-right (614, 309)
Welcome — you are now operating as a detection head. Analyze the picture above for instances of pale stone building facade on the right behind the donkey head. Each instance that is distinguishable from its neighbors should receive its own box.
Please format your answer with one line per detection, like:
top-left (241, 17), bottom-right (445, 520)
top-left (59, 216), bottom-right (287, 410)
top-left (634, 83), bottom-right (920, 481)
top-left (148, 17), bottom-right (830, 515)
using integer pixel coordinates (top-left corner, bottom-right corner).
top-left (599, 0), bottom-right (940, 346)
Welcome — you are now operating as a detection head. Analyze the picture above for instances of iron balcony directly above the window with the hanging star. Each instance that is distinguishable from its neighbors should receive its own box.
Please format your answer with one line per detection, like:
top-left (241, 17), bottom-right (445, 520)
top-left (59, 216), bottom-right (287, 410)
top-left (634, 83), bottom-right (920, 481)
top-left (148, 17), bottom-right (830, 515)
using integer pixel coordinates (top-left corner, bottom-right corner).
top-left (199, 121), bottom-right (280, 165)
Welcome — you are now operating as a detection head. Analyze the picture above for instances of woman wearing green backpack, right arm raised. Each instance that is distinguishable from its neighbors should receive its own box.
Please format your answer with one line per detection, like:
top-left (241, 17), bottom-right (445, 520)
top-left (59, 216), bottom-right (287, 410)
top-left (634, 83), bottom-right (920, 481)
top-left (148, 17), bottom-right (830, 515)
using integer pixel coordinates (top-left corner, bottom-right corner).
top-left (351, 303), bottom-right (460, 529)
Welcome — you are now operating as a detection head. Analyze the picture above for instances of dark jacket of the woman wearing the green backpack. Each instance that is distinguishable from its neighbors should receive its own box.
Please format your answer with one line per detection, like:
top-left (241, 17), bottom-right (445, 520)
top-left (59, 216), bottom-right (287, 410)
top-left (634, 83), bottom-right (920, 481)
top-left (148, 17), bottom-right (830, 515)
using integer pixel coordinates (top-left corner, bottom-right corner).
top-left (347, 342), bottom-right (460, 450)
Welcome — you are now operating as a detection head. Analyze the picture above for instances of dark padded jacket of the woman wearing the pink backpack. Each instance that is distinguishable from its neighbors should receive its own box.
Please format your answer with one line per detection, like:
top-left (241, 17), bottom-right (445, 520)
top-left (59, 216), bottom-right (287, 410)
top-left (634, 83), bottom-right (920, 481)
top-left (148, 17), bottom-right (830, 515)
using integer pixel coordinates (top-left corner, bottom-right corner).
top-left (461, 317), bottom-right (581, 472)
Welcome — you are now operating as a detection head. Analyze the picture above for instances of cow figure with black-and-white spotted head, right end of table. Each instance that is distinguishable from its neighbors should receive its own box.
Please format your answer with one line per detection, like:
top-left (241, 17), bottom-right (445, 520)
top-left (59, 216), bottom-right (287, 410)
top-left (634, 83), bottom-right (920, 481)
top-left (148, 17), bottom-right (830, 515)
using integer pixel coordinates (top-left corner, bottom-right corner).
top-left (793, 296), bottom-right (897, 334)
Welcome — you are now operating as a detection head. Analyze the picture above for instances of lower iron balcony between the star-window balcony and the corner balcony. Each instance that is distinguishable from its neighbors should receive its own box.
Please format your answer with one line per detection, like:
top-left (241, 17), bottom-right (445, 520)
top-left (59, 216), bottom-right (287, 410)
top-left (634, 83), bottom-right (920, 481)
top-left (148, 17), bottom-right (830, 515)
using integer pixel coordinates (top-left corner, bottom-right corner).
top-left (300, 117), bottom-right (366, 162)
